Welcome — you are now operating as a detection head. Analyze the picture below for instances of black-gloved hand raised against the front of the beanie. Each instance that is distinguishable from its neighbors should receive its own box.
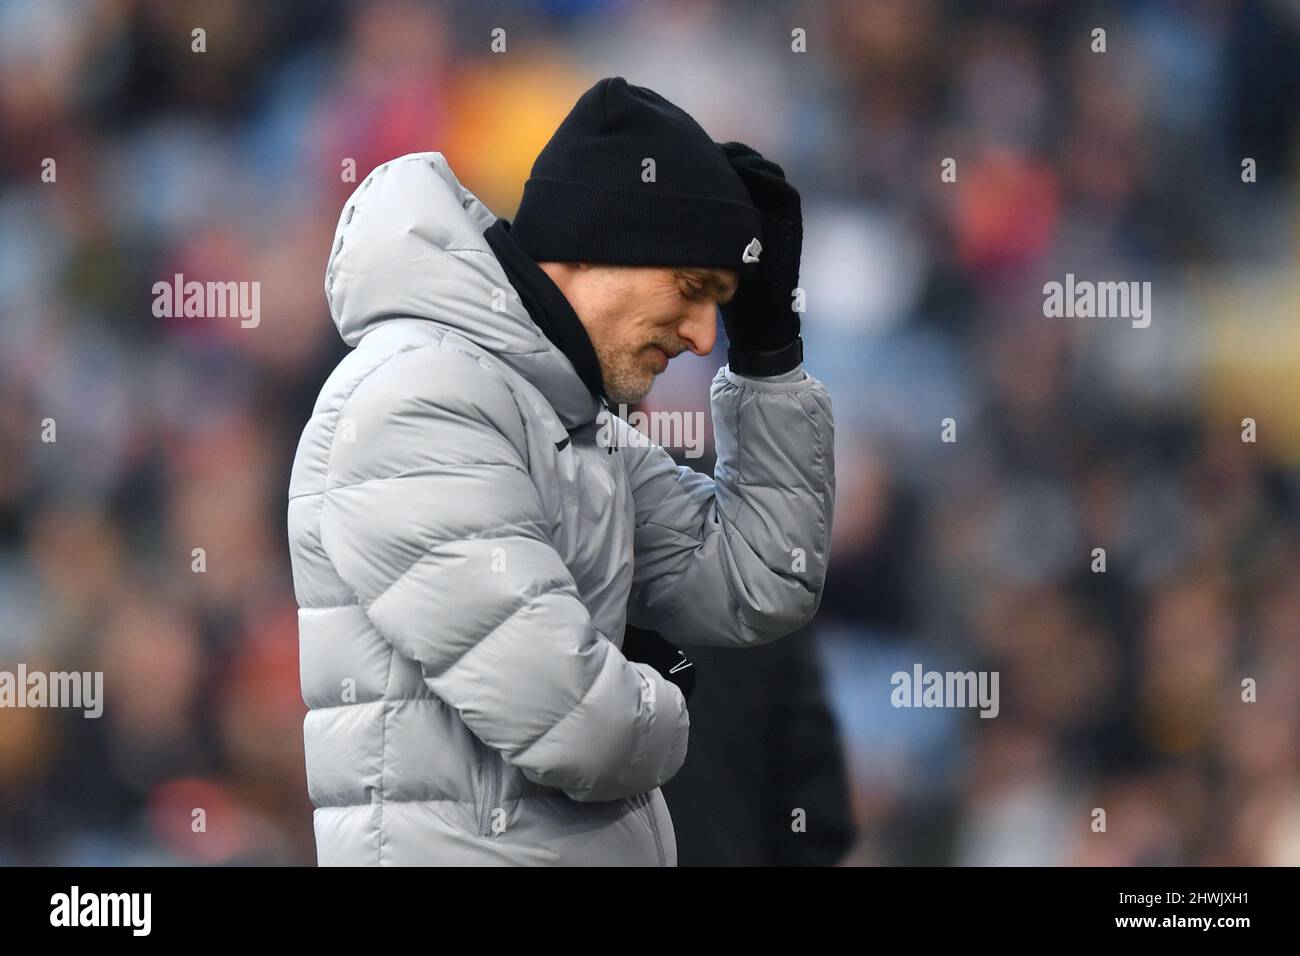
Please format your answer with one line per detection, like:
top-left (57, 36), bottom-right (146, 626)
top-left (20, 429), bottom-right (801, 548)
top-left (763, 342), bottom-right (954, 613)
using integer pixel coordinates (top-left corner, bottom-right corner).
top-left (718, 142), bottom-right (803, 375)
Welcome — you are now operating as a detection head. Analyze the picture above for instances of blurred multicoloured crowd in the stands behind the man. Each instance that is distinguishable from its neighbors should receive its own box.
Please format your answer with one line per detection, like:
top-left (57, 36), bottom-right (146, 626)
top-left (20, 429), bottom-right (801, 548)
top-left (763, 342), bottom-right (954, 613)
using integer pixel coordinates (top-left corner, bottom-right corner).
top-left (0, 0), bottom-right (1300, 865)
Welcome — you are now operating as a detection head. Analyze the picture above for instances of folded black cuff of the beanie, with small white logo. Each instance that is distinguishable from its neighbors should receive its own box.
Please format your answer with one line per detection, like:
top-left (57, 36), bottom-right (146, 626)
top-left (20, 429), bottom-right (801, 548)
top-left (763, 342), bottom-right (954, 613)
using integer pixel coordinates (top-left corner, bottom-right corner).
top-left (511, 177), bottom-right (763, 272)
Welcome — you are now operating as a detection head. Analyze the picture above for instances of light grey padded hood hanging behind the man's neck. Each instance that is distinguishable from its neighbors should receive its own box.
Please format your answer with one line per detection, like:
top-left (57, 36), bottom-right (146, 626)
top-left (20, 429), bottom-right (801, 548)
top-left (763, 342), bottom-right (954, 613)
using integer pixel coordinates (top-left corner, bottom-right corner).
top-left (325, 152), bottom-right (599, 428)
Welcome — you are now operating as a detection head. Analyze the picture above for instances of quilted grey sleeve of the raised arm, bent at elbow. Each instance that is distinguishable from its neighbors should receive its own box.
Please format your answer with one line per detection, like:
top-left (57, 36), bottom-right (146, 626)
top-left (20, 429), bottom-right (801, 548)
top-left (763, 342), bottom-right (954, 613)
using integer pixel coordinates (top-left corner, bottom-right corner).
top-left (624, 365), bottom-right (835, 646)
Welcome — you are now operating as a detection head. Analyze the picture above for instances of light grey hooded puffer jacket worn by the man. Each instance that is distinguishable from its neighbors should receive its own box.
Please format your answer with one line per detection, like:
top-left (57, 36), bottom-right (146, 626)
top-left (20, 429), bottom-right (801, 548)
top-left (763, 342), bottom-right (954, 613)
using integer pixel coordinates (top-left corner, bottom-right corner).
top-left (289, 152), bottom-right (835, 865)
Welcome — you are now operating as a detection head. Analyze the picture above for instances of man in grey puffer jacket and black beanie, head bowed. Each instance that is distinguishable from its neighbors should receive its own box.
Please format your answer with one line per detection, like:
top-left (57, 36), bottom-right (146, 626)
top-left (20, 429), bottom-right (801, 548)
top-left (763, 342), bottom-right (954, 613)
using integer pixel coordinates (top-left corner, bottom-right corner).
top-left (289, 78), bottom-right (835, 865)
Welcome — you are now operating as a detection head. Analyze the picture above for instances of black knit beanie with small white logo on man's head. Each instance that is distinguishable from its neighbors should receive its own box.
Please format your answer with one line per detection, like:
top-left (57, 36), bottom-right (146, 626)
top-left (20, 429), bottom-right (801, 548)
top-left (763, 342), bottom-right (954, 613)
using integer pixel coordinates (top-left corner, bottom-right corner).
top-left (511, 77), bottom-right (762, 276)
